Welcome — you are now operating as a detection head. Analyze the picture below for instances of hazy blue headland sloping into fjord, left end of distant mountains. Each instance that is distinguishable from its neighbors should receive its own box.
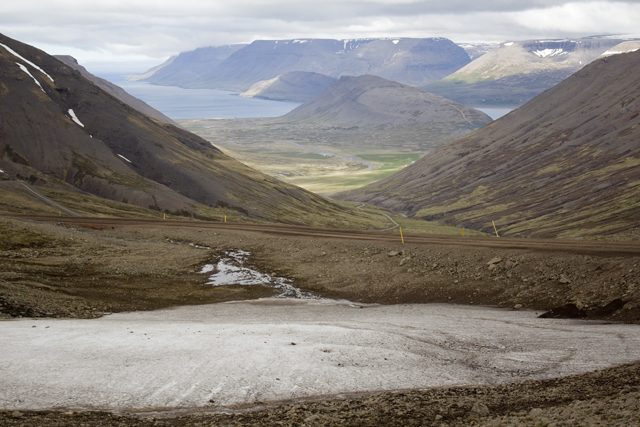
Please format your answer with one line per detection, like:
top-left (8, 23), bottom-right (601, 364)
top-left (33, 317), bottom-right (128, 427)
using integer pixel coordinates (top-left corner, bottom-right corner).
top-left (127, 44), bottom-right (246, 87)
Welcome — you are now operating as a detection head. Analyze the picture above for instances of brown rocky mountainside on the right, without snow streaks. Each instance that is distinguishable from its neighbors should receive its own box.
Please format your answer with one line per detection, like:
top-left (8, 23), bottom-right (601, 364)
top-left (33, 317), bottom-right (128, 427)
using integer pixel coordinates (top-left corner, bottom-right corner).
top-left (339, 52), bottom-right (640, 236)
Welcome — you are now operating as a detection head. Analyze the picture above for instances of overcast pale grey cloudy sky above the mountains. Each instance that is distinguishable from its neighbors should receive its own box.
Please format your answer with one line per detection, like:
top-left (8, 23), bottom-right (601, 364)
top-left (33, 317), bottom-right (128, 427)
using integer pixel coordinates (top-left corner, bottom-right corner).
top-left (0, 0), bottom-right (640, 73)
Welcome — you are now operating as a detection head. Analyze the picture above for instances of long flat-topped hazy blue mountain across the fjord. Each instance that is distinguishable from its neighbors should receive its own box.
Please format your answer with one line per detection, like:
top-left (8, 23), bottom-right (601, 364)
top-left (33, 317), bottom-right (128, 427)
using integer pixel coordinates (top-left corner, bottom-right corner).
top-left (138, 38), bottom-right (470, 91)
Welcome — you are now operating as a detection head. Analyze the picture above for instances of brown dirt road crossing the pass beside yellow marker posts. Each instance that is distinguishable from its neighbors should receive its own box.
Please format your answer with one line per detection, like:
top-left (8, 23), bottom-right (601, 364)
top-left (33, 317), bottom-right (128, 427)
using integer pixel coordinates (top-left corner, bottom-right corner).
top-left (20, 216), bottom-right (640, 255)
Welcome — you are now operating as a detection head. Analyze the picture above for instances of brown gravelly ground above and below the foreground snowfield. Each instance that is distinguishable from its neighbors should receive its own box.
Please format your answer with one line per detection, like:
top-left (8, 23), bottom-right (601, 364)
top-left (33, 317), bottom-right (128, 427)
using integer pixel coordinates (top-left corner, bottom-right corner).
top-left (0, 218), bottom-right (640, 426)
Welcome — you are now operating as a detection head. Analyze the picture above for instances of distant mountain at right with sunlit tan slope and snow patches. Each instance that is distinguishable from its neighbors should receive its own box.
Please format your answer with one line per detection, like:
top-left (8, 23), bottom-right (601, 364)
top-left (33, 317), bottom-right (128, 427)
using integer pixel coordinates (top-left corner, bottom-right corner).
top-left (423, 38), bottom-right (621, 106)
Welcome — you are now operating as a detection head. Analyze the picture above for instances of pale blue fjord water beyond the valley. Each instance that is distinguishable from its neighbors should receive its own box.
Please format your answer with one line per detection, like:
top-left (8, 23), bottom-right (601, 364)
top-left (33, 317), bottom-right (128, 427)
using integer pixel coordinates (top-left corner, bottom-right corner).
top-left (99, 73), bottom-right (511, 120)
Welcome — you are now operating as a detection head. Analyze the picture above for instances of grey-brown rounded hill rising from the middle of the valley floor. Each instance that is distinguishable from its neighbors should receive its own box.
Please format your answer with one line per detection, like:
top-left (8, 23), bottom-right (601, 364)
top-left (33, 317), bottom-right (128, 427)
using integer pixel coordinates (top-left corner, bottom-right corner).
top-left (279, 75), bottom-right (491, 132)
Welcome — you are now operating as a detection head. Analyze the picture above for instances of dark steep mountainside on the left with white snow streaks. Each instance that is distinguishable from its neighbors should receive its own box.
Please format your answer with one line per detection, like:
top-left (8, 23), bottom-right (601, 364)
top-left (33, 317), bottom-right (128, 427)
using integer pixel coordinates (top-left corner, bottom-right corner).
top-left (0, 35), bottom-right (370, 223)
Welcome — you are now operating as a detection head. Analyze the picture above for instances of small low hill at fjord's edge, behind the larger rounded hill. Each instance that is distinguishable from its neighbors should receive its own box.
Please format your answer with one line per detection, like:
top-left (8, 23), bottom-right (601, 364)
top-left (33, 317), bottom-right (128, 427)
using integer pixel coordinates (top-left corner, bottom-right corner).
top-left (240, 71), bottom-right (336, 102)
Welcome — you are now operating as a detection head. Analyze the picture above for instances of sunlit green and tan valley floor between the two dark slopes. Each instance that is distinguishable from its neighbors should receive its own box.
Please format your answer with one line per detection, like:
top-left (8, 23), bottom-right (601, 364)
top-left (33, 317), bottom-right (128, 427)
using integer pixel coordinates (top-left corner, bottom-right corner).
top-left (179, 119), bottom-right (432, 195)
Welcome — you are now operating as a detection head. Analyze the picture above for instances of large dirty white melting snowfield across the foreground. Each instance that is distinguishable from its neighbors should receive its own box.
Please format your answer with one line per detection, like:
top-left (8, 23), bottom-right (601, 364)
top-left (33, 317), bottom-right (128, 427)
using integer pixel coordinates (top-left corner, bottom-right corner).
top-left (0, 299), bottom-right (640, 411)
